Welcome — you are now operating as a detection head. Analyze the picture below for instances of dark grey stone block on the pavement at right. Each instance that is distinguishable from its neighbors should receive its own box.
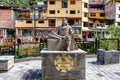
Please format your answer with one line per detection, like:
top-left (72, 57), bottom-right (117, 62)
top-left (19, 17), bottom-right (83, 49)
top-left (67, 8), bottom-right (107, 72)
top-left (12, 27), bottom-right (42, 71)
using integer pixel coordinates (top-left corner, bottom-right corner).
top-left (97, 49), bottom-right (120, 64)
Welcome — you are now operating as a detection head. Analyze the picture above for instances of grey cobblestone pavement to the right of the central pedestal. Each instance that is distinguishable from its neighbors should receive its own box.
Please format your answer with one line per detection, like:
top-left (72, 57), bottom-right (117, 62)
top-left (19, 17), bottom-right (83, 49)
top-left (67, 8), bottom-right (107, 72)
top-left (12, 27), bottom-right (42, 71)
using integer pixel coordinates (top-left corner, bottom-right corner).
top-left (86, 58), bottom-right (120, 80)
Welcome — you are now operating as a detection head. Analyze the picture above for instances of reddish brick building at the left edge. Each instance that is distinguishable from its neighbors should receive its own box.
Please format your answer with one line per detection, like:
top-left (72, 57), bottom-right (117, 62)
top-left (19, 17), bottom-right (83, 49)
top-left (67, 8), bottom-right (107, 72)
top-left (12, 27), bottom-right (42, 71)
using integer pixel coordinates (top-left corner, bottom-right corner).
top-left (0, 6), bottom-right (15, 38)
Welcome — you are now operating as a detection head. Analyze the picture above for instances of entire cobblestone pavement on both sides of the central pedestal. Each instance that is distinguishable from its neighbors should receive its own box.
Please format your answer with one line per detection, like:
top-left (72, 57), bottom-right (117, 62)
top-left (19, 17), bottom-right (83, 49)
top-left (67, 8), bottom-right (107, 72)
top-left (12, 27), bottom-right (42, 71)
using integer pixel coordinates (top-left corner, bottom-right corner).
top-left (0, 58), bottom-right (120, 80)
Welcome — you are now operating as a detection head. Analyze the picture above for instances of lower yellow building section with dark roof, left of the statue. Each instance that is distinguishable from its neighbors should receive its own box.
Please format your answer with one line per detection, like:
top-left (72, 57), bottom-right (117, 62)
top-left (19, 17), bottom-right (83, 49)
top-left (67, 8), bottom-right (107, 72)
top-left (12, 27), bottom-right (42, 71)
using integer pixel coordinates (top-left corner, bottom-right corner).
top-left (14, 3), bottom-right (47, 43)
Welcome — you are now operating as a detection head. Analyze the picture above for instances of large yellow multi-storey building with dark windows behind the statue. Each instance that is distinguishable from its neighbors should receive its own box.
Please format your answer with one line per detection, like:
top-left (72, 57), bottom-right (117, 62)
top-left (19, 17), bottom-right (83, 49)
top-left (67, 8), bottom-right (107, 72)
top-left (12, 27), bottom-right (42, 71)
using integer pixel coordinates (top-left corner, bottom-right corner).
top-left (15, 0), bottom-right (88, 42)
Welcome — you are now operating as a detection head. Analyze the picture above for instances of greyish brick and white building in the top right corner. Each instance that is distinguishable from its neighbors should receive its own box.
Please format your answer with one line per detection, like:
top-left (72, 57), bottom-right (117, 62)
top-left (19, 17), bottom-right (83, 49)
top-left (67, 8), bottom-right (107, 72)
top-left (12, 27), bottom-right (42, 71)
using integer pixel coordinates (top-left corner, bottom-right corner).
top-left (105, 0), bottom-right (120, 26)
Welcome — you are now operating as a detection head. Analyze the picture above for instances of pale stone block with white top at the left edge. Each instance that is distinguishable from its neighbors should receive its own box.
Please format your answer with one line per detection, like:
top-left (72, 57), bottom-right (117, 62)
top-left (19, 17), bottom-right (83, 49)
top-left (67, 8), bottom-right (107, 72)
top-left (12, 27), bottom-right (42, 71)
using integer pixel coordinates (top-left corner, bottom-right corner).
top-left (0, 56), bottom-right (14, 70)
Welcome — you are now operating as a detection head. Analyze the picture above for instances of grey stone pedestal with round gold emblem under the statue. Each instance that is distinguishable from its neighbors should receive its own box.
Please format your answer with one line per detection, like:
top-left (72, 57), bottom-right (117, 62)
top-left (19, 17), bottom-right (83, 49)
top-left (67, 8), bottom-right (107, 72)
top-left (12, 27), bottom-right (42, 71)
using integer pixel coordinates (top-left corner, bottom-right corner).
top-left (41, 49), bottom-right (86, 80)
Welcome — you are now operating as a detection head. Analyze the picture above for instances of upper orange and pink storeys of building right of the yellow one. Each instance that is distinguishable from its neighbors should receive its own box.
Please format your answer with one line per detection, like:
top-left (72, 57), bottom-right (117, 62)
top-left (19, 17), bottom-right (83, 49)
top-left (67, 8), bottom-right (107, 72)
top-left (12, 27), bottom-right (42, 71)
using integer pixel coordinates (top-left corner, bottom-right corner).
top-left (88, 0), bottom-right (105, 28)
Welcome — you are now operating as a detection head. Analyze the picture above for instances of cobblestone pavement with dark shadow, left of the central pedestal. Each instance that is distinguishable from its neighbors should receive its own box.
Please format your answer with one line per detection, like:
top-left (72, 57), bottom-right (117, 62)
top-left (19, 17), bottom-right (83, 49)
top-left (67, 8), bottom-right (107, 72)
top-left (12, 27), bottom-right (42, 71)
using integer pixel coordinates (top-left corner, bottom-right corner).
top-left (0, 60), bottom-right (41, 80)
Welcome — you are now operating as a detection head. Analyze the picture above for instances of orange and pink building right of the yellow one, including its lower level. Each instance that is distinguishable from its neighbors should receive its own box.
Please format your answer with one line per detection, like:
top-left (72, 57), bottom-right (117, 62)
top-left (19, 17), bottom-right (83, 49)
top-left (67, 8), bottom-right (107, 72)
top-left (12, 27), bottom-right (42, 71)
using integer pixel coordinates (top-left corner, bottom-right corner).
top-left (88, 0), bottom-right (105, 38)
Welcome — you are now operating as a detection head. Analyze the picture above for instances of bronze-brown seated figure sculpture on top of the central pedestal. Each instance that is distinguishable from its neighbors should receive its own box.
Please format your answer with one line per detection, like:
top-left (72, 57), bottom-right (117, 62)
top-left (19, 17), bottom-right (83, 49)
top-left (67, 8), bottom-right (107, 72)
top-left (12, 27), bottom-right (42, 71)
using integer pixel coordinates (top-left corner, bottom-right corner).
top-left (48, 19), bottom-right (78, 51)
